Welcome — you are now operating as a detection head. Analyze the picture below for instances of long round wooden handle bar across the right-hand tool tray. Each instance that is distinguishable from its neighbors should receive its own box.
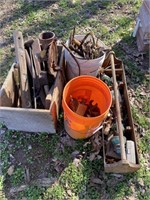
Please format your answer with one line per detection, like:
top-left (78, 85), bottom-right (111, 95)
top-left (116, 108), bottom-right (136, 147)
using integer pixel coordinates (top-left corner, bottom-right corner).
top-left (110, 52), bottom-right (126, 160)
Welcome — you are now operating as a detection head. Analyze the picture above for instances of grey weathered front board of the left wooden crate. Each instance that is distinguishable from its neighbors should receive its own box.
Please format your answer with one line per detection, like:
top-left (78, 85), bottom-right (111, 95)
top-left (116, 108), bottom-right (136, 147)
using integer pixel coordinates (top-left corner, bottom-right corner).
top-left (0, 107), bottom-right (56, 133)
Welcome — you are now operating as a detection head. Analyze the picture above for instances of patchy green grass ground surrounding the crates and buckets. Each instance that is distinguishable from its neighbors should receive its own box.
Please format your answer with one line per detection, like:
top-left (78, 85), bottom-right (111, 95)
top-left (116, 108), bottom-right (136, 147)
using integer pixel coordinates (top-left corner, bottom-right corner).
top-left (0, 0), bottom-right (150, 200)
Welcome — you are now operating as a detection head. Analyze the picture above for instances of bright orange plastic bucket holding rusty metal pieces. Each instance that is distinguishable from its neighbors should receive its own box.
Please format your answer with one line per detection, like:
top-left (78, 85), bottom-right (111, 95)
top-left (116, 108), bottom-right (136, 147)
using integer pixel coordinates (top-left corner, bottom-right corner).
top-left (62, 75), bottom-right (112, 139)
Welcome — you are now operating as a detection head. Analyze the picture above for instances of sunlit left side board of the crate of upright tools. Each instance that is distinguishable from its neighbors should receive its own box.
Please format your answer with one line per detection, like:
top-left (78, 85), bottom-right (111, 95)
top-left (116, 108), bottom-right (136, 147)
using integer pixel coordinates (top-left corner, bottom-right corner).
top-left (0, 64), bottom-right (14, 107)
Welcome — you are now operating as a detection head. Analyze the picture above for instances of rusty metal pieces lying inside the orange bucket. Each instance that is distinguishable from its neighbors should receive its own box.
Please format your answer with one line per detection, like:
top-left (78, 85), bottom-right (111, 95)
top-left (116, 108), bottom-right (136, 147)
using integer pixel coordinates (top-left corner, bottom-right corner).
top-left (69, 96), bottom-right (100, 117)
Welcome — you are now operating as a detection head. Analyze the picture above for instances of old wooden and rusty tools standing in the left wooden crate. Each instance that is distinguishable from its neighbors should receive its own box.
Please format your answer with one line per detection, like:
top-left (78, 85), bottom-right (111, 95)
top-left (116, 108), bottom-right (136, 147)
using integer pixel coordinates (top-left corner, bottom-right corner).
top-left (13, 31), bottom-right (59, 109)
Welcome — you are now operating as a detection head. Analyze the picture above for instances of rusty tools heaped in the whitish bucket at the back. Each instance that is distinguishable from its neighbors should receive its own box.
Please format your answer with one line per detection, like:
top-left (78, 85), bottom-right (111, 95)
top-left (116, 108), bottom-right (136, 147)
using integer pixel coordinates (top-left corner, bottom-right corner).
top-left (64, 29), bottom-right (104, 60)
